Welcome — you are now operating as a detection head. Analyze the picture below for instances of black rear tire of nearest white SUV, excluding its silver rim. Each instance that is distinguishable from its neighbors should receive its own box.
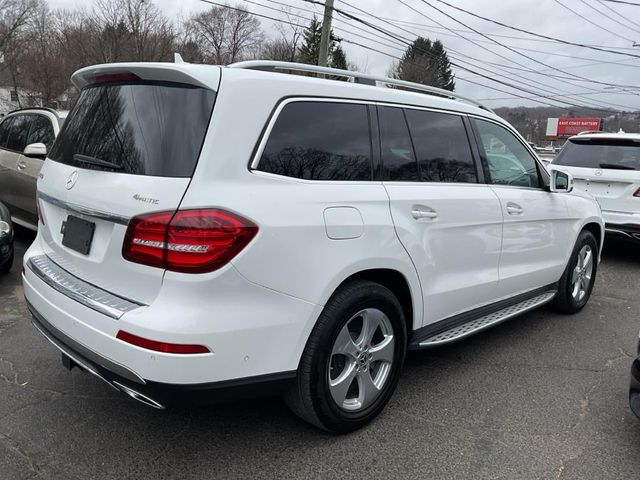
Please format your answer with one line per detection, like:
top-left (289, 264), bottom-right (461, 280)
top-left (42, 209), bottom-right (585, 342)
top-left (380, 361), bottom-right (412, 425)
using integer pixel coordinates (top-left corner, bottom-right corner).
top-left (284, 281), bottom-right (407, 433)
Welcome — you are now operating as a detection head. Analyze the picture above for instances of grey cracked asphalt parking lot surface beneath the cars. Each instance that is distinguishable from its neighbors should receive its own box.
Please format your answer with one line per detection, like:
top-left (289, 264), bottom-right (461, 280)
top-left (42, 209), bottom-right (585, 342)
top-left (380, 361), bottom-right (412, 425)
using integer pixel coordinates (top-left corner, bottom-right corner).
top-left (0, 232), bottom-right (640, 480)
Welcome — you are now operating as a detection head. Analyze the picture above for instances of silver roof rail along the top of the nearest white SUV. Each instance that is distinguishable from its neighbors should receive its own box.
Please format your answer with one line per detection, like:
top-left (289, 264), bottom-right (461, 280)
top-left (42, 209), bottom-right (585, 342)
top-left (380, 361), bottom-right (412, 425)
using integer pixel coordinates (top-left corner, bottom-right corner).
top-left (228, 60), bottom-right (493, 112)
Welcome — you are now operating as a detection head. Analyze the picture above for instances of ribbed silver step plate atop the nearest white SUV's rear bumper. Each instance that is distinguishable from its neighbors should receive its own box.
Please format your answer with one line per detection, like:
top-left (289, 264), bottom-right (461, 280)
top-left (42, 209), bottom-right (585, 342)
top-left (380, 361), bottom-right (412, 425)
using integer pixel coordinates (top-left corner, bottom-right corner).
top-left (27, 255), bottom-right (143, 320)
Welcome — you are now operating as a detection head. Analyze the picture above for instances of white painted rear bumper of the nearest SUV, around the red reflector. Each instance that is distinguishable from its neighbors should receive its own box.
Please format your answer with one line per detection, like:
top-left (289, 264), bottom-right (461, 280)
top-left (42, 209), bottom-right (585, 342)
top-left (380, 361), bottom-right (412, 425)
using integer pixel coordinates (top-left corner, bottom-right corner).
top-left (22, 242), bottom-right (322, 391)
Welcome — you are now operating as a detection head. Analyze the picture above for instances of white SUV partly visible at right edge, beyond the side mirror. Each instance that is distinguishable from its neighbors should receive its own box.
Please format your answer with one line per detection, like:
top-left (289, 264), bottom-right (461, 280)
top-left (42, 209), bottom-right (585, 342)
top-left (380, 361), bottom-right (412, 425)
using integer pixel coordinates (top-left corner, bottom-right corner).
top-left (552, 132), bottom-right (640, 240)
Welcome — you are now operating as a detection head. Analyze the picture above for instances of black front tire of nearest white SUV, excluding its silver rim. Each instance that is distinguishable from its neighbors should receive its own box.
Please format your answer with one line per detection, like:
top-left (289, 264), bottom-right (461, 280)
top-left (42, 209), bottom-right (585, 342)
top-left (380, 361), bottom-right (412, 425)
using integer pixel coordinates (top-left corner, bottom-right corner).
top-left (553, 230), bottom-right (598, 314)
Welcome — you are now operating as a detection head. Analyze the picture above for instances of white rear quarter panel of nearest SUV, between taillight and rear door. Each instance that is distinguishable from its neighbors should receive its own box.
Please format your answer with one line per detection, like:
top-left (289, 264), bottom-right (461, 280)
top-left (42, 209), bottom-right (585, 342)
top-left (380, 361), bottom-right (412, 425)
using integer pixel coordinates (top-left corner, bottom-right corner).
top-left (176, 69), bottom-right (422, 330)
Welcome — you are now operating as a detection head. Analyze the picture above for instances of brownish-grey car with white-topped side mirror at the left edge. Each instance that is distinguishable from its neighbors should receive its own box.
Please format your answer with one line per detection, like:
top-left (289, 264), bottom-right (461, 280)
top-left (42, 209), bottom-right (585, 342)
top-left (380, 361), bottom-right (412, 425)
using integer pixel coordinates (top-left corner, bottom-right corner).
top-left (0, 108), bottom-right (67, 230)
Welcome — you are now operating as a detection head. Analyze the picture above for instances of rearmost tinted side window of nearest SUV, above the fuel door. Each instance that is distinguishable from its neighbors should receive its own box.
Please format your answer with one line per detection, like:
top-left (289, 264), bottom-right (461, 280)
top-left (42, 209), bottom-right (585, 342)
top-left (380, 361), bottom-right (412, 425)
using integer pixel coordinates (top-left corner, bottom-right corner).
top-left (258, 102), bottom-right (372, 180)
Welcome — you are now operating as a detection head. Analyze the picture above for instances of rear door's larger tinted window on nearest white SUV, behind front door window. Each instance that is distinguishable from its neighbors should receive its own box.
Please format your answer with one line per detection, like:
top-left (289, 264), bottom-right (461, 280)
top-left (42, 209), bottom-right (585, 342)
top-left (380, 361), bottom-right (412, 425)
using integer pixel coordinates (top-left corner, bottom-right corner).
top-left (406, 110), bottom-right (478, 183)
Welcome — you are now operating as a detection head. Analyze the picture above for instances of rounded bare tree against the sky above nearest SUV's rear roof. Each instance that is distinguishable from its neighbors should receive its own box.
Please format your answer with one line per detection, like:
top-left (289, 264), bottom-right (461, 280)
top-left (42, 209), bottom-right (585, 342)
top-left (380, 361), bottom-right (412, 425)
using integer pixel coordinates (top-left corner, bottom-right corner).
top-left (185, 5), bottom-right (264, 65)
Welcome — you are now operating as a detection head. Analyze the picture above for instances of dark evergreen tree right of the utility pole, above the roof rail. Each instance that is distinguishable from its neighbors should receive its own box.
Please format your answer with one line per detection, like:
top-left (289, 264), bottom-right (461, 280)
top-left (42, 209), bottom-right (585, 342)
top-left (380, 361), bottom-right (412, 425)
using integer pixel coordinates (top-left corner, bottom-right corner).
top-left (393, 37), bottom-right (456, 91)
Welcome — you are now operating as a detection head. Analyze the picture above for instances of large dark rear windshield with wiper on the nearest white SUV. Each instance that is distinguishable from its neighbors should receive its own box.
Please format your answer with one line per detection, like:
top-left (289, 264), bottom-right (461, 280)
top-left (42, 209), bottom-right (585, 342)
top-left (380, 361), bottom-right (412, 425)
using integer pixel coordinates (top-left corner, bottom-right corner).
top-left (49, 82), bottom-right (215, 177)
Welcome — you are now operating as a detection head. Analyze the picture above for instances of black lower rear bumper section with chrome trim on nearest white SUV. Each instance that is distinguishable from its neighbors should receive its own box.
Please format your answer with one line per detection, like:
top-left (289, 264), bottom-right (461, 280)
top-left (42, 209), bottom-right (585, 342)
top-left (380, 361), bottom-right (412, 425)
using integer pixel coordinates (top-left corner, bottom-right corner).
top-left (27, 303), bottom-right (296, 409)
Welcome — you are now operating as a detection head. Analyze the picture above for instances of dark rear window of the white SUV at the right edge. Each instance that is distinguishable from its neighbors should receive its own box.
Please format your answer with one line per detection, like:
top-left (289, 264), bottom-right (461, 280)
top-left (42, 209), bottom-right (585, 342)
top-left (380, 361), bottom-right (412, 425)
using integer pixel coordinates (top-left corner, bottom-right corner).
top-left (553, 139), bottom-right (640, 170)
